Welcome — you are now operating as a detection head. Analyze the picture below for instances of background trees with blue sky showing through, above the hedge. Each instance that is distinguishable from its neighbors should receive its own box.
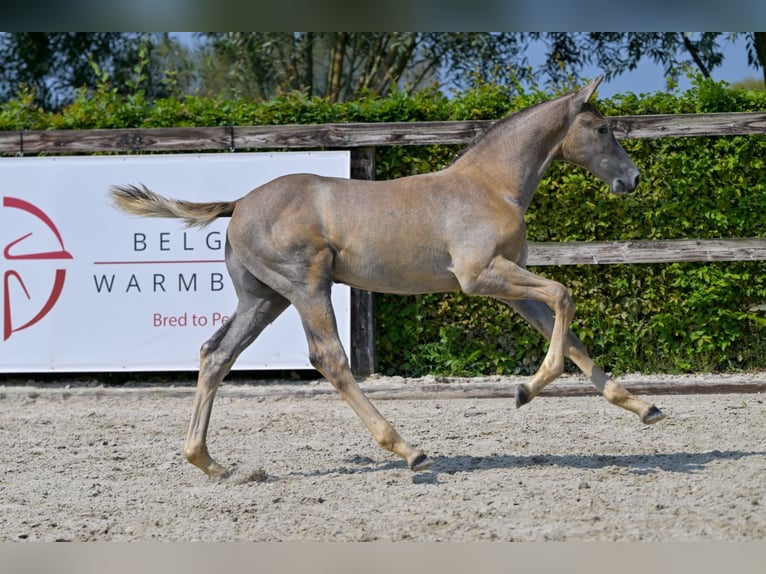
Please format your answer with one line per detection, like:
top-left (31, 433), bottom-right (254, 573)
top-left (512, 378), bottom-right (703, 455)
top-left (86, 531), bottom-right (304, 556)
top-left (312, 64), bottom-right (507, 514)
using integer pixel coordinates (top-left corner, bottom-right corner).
top-left (6, 32), bottom-right (766, 110)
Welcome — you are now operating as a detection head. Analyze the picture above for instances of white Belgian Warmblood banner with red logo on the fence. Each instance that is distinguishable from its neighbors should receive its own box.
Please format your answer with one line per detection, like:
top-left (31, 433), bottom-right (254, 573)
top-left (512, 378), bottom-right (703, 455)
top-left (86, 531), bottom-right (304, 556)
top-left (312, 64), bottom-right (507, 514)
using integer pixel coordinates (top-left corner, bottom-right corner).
top-left (0, 152), bottom-right (350, 373)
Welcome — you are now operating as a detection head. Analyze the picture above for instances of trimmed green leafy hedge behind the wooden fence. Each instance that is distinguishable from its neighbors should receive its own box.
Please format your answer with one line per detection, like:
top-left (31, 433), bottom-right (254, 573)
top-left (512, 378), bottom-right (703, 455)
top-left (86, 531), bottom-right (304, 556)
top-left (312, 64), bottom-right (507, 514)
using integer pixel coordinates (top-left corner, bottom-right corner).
top-left (0, 78), bottom-right (766, 375)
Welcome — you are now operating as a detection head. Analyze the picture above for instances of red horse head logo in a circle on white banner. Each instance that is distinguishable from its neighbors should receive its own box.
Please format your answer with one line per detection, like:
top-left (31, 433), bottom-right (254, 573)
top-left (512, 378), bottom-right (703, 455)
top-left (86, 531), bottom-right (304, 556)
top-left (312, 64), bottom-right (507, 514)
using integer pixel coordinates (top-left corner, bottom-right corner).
top-left (3, 197), bottom-right (72, 341)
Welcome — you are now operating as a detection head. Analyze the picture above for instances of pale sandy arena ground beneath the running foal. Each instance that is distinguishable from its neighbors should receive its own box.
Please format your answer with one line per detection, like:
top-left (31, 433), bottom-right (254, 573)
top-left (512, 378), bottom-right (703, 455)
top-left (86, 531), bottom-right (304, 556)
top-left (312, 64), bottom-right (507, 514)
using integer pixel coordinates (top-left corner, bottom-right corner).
top-left (0, 374), bottom-right (766, 541)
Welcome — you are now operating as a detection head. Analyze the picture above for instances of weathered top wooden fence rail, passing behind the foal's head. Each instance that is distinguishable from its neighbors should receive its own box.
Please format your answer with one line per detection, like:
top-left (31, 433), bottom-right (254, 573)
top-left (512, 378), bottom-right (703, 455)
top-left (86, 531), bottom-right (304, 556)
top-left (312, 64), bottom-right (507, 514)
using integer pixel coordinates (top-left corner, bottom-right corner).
top-left (0, 112), bottom-right (766, 155)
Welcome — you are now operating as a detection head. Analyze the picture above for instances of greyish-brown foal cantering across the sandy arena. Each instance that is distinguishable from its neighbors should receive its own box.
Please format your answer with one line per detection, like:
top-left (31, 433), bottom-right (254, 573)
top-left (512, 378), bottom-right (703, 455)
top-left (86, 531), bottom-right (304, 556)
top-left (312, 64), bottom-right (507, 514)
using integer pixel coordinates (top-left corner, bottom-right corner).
top-left (111, 78), bottom-right (664, 477)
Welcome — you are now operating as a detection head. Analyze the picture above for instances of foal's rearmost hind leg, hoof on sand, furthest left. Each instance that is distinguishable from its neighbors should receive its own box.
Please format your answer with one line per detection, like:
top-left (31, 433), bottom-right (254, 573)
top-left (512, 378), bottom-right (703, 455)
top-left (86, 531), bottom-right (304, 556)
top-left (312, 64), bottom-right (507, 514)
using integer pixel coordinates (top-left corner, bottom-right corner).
top-left (184, 258), bottom-right (289, 478)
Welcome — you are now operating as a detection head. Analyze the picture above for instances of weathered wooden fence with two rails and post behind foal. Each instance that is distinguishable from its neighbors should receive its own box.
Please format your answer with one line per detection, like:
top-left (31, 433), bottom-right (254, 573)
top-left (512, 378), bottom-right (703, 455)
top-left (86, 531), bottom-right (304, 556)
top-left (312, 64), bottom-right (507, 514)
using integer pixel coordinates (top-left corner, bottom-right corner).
top-left (0, 112), bottom-right (766, 375)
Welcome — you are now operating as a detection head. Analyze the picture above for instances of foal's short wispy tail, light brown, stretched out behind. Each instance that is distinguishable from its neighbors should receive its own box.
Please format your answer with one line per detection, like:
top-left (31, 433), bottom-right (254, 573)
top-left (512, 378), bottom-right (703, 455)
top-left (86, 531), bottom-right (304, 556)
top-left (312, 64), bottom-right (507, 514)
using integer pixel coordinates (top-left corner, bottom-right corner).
top-left (109, 185), bottom-right (237, 227)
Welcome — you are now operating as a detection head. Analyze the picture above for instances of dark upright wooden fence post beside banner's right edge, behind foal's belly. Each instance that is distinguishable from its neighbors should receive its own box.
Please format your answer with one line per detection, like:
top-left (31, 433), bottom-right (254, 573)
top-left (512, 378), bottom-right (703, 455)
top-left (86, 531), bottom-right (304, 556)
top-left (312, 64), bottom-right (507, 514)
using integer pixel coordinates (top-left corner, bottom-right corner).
top-left (350, 147), bottom-right (375, 377)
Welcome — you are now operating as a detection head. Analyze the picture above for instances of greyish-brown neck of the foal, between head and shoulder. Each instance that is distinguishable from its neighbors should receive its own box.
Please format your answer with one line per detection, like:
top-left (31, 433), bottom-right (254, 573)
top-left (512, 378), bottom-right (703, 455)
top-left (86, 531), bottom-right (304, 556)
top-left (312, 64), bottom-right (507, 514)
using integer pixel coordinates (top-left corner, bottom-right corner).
top-left (454, 96), bottom-right (569, 211)
